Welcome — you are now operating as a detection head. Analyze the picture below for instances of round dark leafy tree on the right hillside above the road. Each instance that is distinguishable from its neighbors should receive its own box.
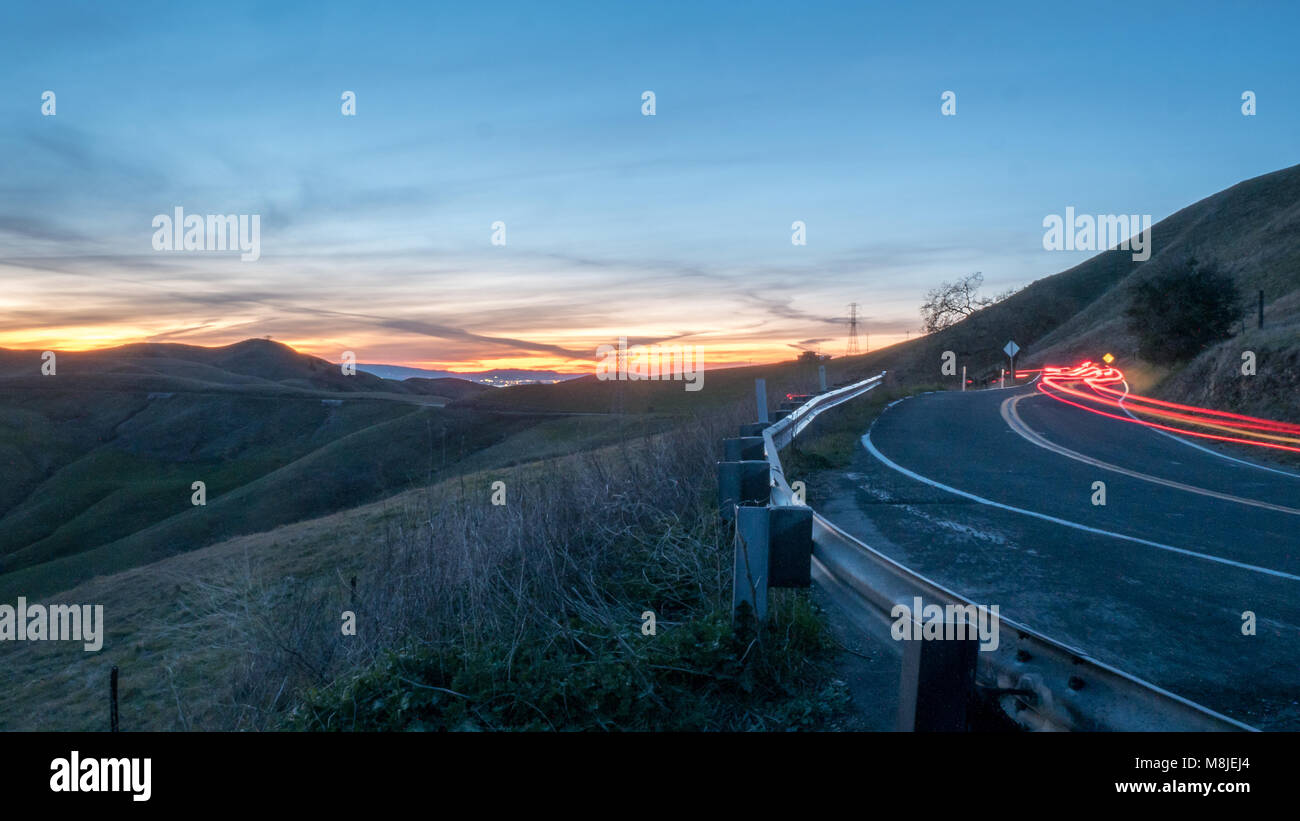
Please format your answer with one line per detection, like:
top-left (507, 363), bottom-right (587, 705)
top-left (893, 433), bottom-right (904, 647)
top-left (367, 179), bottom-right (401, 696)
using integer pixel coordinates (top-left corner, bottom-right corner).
top-left (1125, 257), bottom-right (1242, 365)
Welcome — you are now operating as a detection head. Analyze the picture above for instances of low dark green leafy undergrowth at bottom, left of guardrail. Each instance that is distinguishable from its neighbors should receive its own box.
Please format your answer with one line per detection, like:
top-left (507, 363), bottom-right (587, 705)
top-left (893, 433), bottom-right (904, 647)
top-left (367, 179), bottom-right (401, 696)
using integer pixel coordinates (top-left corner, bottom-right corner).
top-left (291, 591), bottom-right (849, 731)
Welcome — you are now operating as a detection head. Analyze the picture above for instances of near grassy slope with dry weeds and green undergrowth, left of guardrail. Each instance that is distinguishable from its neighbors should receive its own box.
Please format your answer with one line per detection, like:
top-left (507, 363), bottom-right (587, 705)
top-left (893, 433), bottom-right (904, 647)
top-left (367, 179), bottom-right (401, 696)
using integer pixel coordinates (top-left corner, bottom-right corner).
top-left (0, 411), bottom-right (853, 731)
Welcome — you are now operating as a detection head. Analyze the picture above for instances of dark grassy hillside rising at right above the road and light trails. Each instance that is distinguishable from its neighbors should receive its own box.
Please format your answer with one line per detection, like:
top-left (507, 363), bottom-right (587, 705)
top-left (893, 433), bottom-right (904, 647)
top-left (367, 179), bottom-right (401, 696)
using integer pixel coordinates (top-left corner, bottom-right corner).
top-left (790, 166), bottom-right (1300, 420)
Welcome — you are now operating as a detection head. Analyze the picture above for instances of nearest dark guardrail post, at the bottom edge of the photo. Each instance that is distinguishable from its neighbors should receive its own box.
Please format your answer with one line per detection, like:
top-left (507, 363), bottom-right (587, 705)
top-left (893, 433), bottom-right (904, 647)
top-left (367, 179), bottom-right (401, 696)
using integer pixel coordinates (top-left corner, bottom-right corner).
top-left (898, 613), bottom-right (979, 733)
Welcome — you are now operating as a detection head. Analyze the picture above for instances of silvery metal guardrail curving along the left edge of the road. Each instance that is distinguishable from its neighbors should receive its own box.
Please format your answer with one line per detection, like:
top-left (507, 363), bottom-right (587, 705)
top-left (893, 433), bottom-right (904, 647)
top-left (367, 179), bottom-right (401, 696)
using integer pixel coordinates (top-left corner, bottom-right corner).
top-left (763, 373), bottom-right (1255, 731)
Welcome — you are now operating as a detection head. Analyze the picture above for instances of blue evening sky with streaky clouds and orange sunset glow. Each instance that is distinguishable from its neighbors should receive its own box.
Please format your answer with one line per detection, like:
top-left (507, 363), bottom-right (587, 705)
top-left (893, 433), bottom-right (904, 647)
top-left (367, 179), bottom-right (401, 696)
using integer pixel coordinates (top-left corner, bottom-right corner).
top-left (0, 0), bottom-right (1300, 372)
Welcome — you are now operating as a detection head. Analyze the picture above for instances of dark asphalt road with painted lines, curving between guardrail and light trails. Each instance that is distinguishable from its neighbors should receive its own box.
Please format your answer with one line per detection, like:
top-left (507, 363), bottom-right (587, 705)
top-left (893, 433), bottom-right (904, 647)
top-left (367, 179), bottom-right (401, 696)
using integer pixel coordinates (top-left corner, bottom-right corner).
top-left (815, 388), bottom-right (1300, 730)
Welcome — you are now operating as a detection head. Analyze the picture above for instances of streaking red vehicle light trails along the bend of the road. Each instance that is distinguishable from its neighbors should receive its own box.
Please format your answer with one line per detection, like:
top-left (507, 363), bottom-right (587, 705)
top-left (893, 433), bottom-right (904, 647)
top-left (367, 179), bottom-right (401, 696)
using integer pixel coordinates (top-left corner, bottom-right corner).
top-left (1034, 361), bottom-right (1300, 453)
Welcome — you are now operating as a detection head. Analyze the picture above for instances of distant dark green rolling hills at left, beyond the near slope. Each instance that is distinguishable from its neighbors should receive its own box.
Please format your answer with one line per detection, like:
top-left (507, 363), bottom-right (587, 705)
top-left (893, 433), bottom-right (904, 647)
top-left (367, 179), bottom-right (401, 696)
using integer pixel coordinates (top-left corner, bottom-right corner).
top-left (0, 340), bottom-right (657, 596)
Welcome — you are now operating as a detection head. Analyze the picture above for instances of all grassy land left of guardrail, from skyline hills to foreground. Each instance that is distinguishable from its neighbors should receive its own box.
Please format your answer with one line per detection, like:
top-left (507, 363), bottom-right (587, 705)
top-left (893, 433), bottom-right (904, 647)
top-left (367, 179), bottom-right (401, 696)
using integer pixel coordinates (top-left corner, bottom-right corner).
top-left (0, 332), bottom-right (846, 730)
